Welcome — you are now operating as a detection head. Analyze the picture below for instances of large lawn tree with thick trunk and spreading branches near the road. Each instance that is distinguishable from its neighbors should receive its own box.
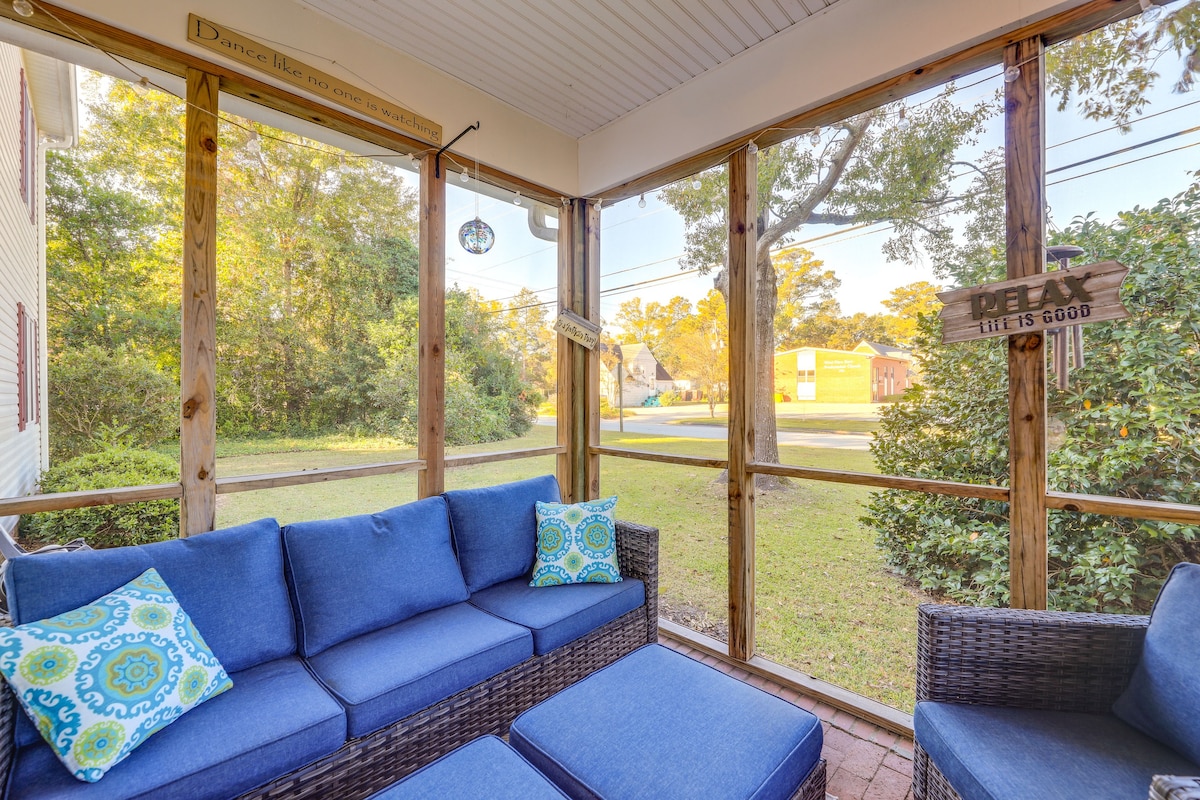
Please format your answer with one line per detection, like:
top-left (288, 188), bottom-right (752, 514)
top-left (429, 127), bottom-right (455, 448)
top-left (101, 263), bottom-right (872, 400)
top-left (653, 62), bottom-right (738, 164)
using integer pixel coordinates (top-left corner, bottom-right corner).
top-left (660, 91), bottom-right (998, 487)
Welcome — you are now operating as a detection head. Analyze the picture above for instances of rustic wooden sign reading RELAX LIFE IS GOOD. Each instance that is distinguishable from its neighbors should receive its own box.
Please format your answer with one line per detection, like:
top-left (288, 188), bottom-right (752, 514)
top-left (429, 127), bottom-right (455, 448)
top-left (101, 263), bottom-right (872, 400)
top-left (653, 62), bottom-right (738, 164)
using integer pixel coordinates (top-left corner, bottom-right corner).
top-left (937, 261), bottom-right (1129, 344)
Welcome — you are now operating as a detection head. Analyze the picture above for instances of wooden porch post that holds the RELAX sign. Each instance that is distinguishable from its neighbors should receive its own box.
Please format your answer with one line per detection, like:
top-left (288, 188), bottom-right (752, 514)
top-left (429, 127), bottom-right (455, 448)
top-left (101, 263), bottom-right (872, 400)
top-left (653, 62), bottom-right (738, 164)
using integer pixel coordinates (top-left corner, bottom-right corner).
top-left (1004, 37), bottom-right (1048, 608)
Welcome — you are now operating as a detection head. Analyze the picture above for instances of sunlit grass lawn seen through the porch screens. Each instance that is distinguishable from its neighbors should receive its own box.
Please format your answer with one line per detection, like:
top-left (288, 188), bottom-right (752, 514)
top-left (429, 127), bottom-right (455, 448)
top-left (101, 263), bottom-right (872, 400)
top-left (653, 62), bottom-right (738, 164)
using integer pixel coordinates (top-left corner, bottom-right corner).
top-left (217, 426), bottom-right (922, 710)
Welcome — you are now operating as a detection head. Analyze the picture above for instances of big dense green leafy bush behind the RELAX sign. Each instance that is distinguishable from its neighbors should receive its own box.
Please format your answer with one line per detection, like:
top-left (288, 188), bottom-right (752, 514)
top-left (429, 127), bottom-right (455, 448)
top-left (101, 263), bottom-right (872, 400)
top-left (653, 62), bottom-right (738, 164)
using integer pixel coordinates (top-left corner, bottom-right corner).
top-left (864, 188), bottom-right (1200, 613)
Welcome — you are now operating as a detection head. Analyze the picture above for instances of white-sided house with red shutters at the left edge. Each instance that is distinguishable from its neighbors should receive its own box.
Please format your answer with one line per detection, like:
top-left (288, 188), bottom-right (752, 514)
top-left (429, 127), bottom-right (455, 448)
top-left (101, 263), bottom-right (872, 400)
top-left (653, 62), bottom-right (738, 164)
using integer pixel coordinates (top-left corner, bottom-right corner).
top-left (0, 43), bottom-right (78, 554)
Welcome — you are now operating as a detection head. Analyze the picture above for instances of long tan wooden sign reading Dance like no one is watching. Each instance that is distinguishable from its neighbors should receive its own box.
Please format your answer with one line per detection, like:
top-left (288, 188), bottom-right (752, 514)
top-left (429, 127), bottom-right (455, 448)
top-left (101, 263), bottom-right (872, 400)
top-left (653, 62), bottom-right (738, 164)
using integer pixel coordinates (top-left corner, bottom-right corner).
top-left (187, 14), bottom-right (442, 145)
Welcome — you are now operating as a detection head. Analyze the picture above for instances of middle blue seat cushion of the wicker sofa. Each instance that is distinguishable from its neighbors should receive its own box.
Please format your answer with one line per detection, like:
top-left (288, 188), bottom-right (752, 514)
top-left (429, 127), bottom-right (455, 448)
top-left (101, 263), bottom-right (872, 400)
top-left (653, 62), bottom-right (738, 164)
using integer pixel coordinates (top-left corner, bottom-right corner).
top-left (308, 603), bottom-right (533, 736)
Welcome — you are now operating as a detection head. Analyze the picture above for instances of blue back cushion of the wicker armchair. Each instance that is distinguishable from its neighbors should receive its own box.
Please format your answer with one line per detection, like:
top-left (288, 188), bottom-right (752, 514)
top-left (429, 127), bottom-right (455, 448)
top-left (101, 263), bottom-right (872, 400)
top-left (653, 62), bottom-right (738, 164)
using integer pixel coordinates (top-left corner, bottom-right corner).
top-left (1112, 564), bottom-right (1200, 763)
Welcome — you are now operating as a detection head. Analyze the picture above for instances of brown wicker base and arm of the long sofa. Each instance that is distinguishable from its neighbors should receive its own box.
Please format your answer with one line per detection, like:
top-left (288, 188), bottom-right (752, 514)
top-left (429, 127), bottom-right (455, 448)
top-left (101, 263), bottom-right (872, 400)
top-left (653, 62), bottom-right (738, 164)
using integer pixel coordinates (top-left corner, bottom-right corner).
top-left (0, 521), bottom-right (659, 800)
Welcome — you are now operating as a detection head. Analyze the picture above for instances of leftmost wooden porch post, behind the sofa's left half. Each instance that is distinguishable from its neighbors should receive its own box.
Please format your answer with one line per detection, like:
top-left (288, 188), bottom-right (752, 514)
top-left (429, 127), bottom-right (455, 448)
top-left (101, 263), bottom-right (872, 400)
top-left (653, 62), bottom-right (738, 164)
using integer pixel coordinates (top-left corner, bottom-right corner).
top-left (179, 68), bottom-right (220, 536)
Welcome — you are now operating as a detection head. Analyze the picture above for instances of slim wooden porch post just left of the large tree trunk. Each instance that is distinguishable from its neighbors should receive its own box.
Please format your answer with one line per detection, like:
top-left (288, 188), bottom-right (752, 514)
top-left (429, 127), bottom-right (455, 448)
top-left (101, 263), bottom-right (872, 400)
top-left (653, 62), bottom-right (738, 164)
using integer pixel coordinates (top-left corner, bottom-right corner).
top-left (728, 148), bottom-right (753, 661)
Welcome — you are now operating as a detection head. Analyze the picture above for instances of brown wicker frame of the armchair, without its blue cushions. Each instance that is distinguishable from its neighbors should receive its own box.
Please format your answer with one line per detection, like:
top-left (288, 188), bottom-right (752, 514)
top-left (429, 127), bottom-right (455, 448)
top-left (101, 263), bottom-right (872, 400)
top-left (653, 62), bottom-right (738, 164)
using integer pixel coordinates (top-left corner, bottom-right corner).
top-left (913, 604), bottom-right (1200, 800)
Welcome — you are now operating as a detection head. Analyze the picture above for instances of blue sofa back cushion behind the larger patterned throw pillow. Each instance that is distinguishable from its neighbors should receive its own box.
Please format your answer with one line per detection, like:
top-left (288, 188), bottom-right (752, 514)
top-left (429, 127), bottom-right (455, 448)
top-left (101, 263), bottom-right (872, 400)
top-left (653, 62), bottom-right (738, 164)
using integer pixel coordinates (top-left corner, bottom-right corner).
top-left (5, 519), bottom-right (296, 673)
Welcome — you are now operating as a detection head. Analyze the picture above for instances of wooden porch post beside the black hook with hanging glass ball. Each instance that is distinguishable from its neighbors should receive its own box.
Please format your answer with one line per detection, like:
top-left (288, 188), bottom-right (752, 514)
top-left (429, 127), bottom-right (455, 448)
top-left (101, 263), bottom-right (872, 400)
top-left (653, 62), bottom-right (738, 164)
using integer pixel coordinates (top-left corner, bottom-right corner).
top-left (416, 152), bottom-right (446, 498)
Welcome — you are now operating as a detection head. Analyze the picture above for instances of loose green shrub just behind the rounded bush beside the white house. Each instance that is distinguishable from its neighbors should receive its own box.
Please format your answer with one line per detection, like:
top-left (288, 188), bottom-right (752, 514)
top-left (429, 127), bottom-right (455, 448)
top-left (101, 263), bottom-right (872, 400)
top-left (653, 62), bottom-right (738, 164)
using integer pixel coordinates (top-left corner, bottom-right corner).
top-left (48, 344), bottom-right (179, 458)
